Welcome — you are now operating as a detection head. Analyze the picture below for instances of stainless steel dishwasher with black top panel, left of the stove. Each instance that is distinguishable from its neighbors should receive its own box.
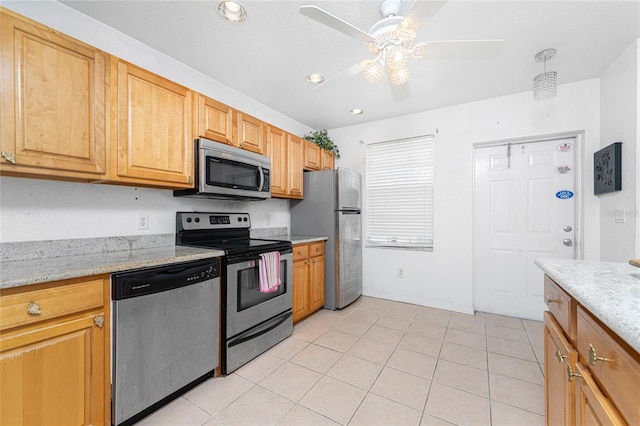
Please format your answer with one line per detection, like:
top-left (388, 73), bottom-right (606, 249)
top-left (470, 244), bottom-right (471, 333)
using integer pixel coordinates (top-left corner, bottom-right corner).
top-left (111, 258), bottom-right (220, 425)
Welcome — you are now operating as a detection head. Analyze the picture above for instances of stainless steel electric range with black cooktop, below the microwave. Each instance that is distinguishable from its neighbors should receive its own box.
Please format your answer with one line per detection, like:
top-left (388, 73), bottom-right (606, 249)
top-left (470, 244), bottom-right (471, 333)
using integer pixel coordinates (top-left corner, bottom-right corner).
top-left (176, 212), bottom-right (293, 374)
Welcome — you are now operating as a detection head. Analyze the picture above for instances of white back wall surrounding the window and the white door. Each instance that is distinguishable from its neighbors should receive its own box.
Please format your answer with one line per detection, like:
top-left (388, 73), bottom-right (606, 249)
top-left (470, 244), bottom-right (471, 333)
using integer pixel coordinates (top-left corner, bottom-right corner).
top-left (330, 79), bottom-right (600, 312)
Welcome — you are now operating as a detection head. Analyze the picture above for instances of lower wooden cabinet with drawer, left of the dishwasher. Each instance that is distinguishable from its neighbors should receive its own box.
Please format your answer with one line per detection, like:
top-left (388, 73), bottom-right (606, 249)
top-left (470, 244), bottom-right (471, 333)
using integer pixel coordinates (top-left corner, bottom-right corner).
top-left (0, 275), bottom-right (110, 425)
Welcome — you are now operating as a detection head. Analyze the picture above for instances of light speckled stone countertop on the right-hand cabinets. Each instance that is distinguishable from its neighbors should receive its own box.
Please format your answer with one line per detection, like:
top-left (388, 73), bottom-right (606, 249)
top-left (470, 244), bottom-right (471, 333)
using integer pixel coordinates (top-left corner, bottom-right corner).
top-left (535, 258), bottom-right (640, 353)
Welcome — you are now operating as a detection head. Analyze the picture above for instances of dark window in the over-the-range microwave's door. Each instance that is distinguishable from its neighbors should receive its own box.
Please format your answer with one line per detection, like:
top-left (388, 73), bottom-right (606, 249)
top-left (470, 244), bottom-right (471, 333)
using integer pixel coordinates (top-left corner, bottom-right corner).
top-left (206, 157), bottom-right (260, 191)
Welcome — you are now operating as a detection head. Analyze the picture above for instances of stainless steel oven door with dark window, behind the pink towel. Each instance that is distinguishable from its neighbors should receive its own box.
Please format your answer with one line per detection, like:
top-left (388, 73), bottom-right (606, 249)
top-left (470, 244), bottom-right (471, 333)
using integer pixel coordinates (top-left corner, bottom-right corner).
top-left (226, 252), bottom-right (293, 339)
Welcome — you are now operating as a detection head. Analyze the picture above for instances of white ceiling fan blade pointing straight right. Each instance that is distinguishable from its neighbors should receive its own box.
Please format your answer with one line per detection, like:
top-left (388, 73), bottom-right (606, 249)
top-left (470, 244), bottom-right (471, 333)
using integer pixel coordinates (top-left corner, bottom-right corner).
top-left (416, 40), bottom-right (505, 59)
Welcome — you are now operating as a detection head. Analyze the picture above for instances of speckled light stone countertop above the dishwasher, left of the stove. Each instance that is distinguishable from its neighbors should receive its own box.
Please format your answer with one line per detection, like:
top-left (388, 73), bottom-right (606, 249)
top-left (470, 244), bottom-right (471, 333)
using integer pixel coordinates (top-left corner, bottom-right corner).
top-left (0, 237), bottom-right (224, 289)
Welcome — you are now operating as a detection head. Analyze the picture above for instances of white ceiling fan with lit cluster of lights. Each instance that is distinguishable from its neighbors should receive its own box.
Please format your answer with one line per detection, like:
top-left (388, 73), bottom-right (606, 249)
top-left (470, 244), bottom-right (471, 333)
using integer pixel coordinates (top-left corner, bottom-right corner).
top-left (300, 0), bottom-right (504, 88)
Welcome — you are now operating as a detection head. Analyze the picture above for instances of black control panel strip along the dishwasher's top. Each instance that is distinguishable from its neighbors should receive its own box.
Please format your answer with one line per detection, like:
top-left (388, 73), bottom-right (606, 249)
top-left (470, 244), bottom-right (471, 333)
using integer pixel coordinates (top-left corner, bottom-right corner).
top-left (111, 258), bottom-right (220, 300)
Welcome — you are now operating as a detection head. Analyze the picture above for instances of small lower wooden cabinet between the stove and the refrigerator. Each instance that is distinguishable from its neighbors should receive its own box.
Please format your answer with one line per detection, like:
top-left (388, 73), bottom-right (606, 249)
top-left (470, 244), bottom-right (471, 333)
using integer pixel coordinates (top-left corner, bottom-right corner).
top-left (293, 241), bottom-right (324, 323)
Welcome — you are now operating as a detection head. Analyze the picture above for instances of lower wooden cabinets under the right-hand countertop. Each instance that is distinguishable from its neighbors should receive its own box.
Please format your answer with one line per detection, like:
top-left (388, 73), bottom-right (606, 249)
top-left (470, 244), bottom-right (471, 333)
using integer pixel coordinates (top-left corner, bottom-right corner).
top-left (544, 276), bottom-right (640, 425)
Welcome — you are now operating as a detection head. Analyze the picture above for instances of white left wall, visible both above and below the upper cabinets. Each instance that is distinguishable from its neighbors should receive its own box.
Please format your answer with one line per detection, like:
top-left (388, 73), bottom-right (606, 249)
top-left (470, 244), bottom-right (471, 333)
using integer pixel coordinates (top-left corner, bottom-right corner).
top-left (0, 1), bottom-right (312, 242)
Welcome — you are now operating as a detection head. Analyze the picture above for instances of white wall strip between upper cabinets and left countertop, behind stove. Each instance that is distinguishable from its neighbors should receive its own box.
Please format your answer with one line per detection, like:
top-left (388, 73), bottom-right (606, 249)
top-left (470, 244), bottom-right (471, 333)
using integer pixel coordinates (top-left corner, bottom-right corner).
top-left (0, 177), bottom-right (290, 243)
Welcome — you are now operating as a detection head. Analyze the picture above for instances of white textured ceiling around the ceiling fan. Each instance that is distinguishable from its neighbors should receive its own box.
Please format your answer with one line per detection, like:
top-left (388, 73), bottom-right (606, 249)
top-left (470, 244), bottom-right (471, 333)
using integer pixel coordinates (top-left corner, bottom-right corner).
top-left (64, 0), bottom-right (640, 129)
